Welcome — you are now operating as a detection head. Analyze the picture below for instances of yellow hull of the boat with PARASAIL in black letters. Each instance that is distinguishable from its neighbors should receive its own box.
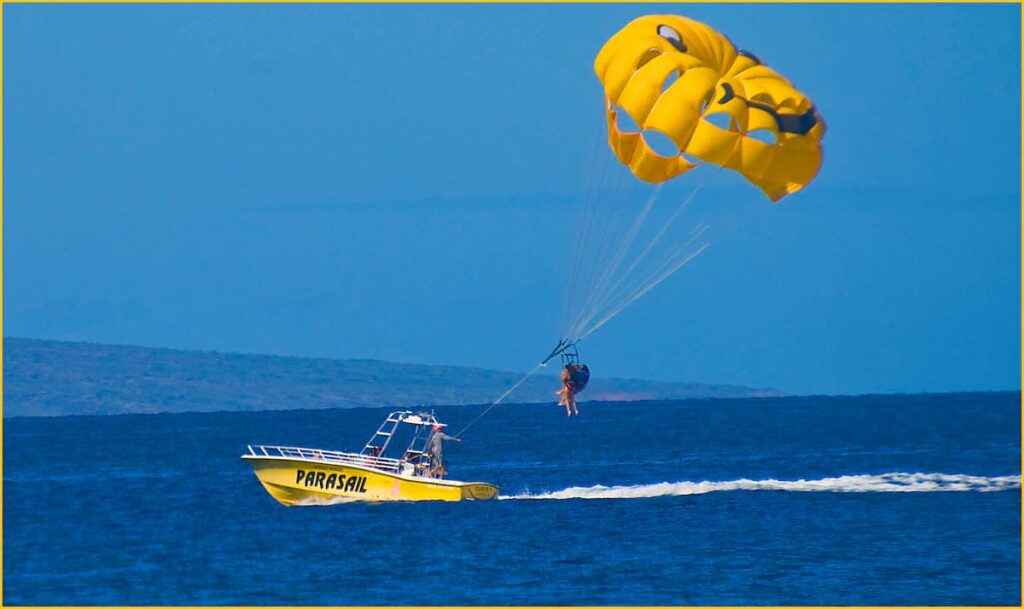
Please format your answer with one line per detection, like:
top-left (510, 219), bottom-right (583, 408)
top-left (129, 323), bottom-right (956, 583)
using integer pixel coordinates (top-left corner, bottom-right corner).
top-left (242, 454), bottom-right (498, 506)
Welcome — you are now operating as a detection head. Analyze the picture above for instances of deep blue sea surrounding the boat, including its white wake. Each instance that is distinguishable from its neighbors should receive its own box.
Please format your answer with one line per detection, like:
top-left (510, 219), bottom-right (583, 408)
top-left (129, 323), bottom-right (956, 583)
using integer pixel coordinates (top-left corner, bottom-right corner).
top-left (3, 393), bottom-right (1021, 605)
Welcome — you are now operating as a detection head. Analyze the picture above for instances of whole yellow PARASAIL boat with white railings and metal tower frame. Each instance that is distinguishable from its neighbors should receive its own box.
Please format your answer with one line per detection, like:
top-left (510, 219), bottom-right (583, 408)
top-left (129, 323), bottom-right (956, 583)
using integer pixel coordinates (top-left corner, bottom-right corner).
top-left (242, 410), bottom-right (498, 506)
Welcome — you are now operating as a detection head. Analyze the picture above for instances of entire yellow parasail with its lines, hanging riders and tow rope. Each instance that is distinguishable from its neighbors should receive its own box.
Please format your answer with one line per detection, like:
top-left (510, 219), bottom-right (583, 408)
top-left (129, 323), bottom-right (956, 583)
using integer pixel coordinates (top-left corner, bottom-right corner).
top-left (458, 15), bottom-right (825, 435)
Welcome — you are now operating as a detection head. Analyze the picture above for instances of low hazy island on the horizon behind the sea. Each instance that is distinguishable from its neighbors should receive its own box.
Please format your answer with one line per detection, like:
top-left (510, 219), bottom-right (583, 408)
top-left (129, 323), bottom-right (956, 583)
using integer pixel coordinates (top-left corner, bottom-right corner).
top-left (3, 338), bottom-right (782, 417)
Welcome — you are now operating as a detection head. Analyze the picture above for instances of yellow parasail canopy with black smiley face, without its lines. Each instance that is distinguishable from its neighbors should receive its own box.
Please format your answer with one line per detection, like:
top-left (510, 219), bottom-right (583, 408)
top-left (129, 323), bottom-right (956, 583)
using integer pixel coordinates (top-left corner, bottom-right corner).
top-left (594, 15), bottom-right (825, 201)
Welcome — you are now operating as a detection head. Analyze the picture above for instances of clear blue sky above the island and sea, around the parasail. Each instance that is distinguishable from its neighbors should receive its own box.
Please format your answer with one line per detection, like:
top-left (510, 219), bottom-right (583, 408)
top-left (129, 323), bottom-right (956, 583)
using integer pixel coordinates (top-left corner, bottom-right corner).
top-left (2, 4), bottom-right (1021, 394)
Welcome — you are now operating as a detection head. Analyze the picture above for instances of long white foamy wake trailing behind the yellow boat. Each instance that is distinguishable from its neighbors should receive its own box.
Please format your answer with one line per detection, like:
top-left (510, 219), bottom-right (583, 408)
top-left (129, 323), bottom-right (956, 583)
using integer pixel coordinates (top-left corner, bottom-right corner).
top-left (498, 472), bottom-right (1021, 499)
